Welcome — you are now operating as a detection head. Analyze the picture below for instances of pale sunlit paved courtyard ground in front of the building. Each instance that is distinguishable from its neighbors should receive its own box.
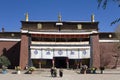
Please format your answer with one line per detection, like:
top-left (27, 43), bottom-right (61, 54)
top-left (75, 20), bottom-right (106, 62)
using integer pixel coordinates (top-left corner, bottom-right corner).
top-left (0, 69), bottom-right (120, 80)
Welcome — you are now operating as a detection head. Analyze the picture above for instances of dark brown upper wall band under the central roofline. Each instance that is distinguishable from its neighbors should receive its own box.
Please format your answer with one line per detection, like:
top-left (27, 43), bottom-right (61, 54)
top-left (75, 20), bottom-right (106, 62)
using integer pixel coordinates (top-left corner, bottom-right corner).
top-left (21, 21), bottom-right (98, 30)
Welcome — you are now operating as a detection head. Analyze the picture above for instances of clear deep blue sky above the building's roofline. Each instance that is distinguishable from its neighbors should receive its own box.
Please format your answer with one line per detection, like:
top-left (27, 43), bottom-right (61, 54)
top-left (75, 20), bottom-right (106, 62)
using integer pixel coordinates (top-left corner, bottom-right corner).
top-left (0, 0), bottom-right (120, 32)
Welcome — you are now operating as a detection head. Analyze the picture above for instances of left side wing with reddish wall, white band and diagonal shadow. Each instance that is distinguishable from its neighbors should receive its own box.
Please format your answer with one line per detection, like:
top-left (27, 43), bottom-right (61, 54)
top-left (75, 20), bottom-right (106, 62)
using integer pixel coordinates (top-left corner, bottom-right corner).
top-left (0, 31), bottom-right (21, 68)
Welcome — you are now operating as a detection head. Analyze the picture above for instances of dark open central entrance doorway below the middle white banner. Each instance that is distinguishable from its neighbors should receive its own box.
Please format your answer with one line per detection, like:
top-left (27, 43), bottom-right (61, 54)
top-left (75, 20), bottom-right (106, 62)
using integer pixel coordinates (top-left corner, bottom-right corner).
top-left (54, 57), bottom-right (67, 68)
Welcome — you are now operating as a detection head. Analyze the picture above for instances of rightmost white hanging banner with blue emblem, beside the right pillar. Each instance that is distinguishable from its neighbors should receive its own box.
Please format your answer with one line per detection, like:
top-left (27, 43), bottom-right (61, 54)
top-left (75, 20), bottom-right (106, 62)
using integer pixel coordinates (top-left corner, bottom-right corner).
top-left (79, 48), bottom-right (90, 59)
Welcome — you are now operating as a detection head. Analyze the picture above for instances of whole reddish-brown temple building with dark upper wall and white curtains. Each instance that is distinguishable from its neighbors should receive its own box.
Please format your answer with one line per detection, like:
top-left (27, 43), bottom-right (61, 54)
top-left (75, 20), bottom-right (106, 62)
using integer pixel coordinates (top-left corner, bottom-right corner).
top-left (0, 15), bottom-right (118, 69)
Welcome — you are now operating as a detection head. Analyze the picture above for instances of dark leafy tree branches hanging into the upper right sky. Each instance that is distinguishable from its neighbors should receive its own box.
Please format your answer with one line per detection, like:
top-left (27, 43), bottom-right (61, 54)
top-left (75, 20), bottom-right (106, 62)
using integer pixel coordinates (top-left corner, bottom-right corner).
top-left (97, 0), bottom-right (120, 25)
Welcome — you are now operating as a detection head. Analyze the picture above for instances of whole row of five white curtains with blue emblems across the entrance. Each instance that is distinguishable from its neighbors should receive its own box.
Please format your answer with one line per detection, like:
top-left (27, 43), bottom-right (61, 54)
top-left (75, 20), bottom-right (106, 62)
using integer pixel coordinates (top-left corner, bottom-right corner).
top-left (31, 46), bottom-right (91, 59)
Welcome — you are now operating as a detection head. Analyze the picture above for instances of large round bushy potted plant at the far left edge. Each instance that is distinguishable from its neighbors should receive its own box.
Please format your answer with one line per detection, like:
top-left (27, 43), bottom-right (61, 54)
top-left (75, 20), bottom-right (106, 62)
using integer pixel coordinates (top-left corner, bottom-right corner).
top-left (0, 55), bottom-right (11, 74)
